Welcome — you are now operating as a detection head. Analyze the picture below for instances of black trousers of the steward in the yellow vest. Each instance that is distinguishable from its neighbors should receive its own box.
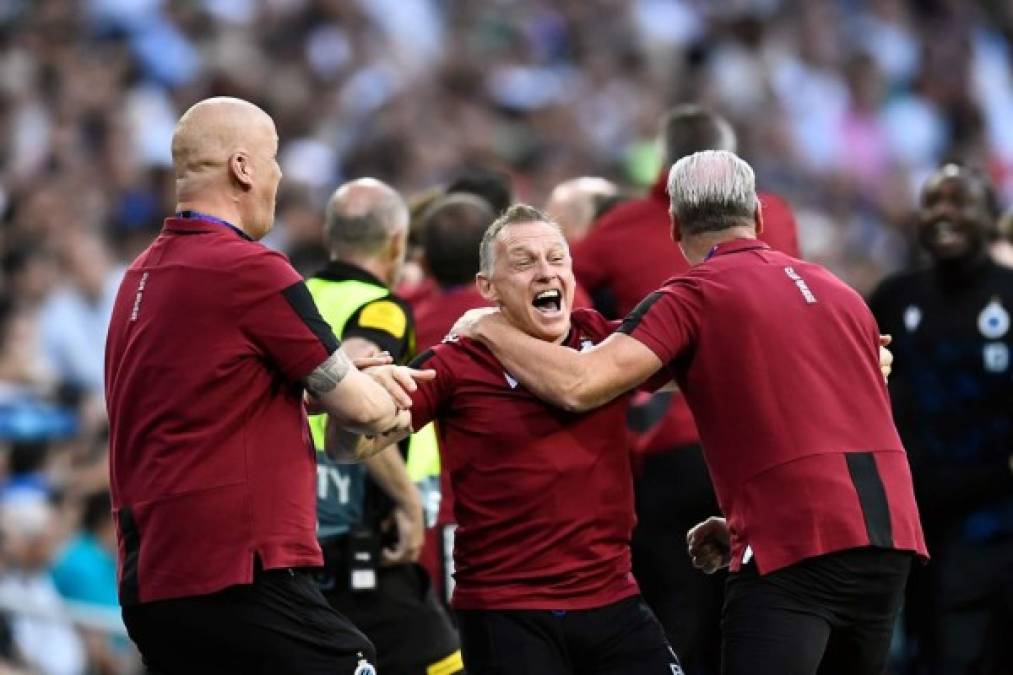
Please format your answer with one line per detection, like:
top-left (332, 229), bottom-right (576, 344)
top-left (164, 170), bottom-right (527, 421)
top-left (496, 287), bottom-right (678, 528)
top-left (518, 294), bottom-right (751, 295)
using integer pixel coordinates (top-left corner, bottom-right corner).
top-left (317, 565), bottom-right (462, 675)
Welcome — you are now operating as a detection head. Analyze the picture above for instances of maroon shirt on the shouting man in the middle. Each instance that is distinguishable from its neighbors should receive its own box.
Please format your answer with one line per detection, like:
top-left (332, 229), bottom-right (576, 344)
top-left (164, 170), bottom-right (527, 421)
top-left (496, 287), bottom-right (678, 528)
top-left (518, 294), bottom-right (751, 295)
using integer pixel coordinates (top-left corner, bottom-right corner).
top-left (411, 309), bottom-right (656, 609)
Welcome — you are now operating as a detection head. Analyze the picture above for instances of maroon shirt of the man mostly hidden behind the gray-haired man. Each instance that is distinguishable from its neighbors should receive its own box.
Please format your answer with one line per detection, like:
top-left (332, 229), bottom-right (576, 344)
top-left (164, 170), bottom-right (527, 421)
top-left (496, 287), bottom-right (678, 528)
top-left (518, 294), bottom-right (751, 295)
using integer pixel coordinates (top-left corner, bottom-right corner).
top-left (572, 176), bottom-right (799, 454)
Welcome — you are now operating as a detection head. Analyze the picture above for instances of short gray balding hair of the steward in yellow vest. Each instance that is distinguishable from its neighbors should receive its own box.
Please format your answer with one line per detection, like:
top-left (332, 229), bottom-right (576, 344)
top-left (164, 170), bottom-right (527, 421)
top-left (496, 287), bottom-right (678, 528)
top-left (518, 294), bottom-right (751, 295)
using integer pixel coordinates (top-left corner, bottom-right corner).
top-left (323, 178), bottom-right (408, 256)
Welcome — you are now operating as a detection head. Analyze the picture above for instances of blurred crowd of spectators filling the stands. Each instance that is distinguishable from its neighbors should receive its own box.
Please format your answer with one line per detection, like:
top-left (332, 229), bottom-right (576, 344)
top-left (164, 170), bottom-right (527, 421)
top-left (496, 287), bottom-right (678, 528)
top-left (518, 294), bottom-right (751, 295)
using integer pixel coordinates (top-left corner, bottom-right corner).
top-left (0, 0), bottom-right (1013, 674)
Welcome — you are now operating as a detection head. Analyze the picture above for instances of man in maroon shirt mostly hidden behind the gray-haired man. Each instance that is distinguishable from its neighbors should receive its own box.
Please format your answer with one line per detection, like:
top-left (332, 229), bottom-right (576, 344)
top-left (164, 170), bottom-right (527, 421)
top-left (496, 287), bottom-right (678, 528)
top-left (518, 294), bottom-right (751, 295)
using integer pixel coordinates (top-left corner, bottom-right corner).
top-left (573, 105), bottom-right (798, 674)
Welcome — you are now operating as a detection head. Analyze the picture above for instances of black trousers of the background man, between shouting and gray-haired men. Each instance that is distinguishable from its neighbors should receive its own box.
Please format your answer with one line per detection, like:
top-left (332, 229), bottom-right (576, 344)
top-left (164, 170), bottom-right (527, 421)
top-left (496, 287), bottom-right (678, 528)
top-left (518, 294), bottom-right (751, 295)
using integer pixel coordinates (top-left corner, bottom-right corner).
top-left (631, 445), bottom-right (725, 675)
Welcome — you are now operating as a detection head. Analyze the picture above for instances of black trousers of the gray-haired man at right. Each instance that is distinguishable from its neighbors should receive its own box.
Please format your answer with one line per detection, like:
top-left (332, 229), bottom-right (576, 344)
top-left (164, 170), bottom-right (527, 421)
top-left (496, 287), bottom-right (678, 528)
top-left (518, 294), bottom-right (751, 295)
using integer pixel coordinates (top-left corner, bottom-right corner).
top-left (721, 548), bottom-right (914, 675)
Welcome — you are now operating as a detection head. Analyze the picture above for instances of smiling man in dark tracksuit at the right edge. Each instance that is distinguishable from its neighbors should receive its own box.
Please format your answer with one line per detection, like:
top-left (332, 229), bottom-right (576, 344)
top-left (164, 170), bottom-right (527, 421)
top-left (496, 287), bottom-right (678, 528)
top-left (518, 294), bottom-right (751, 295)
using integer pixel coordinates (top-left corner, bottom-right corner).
top-left (869, 164), bottom-right (1013, 675)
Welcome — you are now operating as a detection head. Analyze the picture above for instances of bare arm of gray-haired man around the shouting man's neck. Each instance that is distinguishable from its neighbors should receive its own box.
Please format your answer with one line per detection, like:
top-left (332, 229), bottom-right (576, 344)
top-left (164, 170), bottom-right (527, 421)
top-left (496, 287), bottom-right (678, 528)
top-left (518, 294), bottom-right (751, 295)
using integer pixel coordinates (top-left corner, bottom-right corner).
top-left (455, 312), bottom-right (663, 411)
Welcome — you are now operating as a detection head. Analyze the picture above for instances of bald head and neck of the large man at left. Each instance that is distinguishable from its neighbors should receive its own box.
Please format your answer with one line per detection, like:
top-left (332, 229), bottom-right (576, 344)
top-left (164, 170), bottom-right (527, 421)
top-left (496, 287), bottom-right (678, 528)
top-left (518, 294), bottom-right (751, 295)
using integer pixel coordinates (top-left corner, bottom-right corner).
top-left (172, 97), bottom-right (282, 239)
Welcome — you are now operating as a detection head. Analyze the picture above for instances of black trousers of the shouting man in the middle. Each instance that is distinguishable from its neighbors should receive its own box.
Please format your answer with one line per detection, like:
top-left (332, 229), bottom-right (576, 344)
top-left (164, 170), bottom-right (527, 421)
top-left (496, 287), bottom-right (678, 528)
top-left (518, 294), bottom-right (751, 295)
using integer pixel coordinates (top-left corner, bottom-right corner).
top-left (457, 596), bottom-right (683, 675)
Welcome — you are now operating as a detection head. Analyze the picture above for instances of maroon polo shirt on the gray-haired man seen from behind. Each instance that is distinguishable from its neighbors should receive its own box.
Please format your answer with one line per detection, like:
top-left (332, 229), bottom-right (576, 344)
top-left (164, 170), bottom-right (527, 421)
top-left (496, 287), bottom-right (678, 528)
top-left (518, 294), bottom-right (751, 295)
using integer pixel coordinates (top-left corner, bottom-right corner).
top-left (620, 239), bottom-right (926, 574)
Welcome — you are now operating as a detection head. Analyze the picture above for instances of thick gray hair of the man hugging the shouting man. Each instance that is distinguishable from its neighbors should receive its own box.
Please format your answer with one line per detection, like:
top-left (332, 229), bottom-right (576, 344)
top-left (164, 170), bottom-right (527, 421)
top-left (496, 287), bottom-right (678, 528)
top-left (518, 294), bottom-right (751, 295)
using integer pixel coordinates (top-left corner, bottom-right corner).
top-left (669, 150), bottom-right (759, 234)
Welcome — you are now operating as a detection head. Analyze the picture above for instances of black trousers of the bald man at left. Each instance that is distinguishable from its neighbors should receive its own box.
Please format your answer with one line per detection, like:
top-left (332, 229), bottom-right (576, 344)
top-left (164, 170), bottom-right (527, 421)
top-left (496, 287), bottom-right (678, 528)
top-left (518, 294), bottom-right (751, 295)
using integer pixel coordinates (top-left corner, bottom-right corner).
top-left (123, 570), bottom-right (375, 675)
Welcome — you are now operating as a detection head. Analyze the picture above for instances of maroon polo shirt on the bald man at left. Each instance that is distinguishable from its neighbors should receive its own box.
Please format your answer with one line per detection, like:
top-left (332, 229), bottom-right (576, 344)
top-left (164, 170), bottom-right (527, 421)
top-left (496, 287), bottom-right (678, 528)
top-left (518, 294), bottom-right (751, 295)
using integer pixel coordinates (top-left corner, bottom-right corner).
top-left (105, 212), bottom-right (337, 605)
